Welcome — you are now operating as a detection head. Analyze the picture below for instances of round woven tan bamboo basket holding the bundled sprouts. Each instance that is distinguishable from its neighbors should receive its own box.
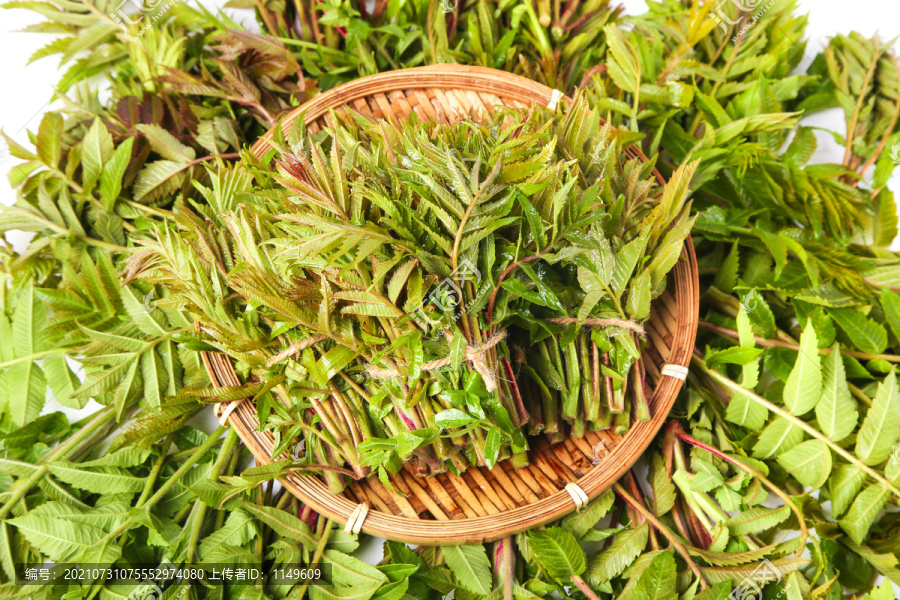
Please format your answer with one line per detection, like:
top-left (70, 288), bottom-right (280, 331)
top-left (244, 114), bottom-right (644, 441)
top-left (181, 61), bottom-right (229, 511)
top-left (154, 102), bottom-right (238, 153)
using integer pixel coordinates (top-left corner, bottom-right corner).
top-left (203, 65), bottom-right (699, 545)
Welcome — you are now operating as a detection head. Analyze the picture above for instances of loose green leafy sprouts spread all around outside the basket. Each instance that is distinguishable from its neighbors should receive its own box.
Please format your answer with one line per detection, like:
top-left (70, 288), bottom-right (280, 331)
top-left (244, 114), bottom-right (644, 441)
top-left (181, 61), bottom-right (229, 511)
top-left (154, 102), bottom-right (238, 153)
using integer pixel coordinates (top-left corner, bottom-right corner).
top-left (0, 0), bottom-right (900, 600)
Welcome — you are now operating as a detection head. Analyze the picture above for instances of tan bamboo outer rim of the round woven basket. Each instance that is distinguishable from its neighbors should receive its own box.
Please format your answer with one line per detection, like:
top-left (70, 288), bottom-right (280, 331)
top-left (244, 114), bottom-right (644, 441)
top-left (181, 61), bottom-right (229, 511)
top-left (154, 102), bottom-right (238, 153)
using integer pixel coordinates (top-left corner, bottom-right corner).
top-left (202, 64), bottom-right (700, 545)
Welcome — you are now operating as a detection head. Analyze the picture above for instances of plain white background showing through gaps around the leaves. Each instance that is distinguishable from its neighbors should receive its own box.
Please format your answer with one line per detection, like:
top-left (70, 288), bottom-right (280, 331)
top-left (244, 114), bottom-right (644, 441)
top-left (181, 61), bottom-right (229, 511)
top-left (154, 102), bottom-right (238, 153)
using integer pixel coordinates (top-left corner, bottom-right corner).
top-left (0, 0), bottom-right (900, 580)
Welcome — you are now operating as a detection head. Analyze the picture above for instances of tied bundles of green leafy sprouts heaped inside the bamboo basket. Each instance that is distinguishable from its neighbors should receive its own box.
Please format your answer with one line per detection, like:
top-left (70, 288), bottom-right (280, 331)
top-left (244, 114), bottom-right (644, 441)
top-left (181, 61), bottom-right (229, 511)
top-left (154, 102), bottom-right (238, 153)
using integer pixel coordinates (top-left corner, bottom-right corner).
top-left (132, 101), bottom-right (692, 490)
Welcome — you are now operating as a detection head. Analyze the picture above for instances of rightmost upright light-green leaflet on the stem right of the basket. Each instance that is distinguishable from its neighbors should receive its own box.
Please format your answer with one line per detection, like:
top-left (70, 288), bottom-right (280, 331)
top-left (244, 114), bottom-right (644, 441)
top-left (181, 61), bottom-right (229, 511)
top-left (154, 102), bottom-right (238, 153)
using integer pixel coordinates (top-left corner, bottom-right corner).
top-left (856, 369), bottom-right (900, 465)
